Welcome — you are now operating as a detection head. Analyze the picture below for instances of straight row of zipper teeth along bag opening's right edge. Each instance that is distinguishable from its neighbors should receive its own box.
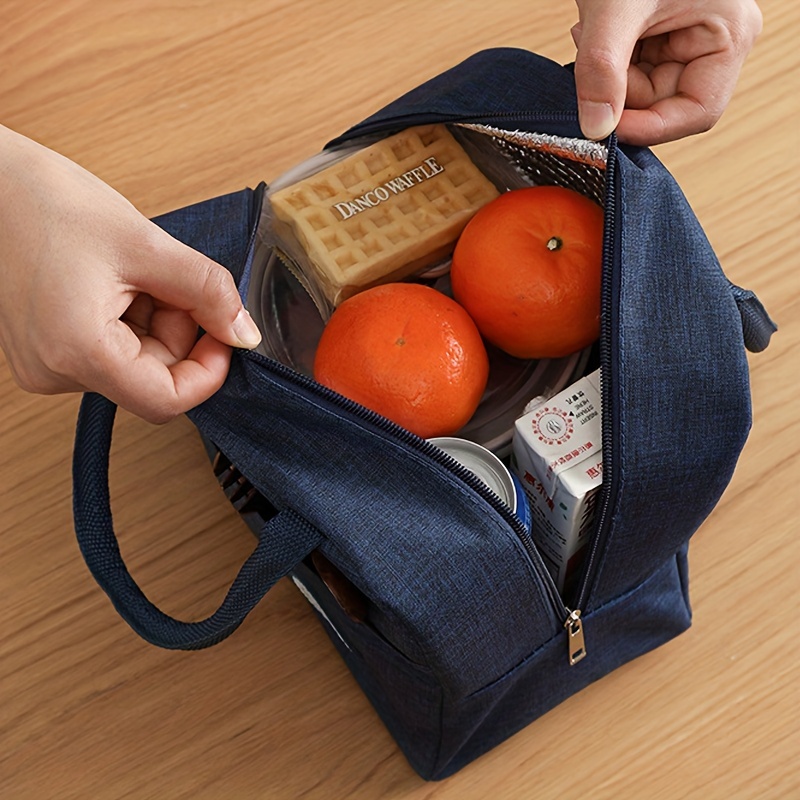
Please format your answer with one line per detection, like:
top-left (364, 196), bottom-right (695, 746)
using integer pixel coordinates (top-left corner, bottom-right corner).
top-left (575, 134), bottom-right (617, 609)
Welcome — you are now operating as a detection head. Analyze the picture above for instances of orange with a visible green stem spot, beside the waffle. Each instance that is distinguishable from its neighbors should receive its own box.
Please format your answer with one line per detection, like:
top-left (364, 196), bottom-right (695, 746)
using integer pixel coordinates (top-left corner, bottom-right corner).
top-left (450, 186), bottom-right (603, 358)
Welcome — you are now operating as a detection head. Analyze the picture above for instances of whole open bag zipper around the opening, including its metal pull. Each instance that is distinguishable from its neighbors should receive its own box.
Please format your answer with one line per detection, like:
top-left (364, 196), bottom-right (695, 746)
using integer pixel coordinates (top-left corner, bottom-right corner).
top-left (253, 112), bottom-right (617, 666)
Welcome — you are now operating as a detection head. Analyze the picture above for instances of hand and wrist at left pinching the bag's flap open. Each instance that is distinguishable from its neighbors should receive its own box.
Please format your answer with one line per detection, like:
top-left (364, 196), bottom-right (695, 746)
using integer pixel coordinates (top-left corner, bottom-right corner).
top-left (0, 126), bottom-right (260, 422)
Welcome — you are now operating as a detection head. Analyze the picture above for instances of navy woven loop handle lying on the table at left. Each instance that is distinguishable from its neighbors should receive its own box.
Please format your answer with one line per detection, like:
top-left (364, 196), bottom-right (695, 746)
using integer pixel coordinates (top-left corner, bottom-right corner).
top-left (73, 394), bottom-right (323, 650)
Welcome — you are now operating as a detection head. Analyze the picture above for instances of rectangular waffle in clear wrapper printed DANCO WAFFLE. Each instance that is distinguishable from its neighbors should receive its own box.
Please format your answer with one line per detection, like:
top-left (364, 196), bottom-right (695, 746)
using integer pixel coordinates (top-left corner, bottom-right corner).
top-left (270, 125), bottom-right (498, 305)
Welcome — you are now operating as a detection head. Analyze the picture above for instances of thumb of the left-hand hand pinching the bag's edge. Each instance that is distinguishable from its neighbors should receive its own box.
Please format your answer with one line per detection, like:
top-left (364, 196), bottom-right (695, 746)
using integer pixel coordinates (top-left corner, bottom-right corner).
top-left (123, 224), bottom-right (261, 350)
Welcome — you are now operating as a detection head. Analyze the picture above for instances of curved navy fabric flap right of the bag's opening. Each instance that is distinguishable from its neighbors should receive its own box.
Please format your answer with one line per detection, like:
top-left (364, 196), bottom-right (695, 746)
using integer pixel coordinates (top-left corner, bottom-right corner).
top-left (590, 150), bottom-right (751, 608)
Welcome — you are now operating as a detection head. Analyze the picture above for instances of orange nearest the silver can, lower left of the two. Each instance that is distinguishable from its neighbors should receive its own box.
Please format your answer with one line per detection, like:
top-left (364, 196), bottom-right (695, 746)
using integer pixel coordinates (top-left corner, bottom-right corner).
top-left (314, 283), bottom-right (489, 438)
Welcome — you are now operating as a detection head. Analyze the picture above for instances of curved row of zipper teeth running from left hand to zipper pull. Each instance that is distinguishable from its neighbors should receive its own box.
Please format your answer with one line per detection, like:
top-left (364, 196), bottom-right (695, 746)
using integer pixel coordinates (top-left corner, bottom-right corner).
top-left (247, 350), bottom-right (569, 622)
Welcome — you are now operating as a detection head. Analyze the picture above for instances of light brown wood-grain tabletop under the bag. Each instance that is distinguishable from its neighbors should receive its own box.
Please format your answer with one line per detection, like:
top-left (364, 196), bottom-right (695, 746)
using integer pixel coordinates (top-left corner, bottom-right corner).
top-left (0, 0), bottom-right (800, 800)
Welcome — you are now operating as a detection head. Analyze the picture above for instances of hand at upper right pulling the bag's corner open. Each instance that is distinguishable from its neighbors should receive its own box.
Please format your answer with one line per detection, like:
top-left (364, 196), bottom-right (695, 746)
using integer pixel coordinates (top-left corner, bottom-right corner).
top-left (572, 0), bottom-right (761, 145)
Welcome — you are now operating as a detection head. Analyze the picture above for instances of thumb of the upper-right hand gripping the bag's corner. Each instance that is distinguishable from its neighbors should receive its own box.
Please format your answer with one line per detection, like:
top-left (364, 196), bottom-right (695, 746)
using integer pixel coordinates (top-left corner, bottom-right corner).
top-left (572, 0), bottom-right (641, 139)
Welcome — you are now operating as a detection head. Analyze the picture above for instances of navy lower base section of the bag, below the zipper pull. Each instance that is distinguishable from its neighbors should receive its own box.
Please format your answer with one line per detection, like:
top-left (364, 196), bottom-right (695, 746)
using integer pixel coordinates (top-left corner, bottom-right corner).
top-left (297, 551), bottom-right (691, 780)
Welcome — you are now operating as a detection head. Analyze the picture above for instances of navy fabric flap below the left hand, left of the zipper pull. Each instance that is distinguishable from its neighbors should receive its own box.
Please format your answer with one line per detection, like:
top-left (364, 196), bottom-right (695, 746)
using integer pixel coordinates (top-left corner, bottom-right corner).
top-left (190, 352), bottom-right (560, 694)
